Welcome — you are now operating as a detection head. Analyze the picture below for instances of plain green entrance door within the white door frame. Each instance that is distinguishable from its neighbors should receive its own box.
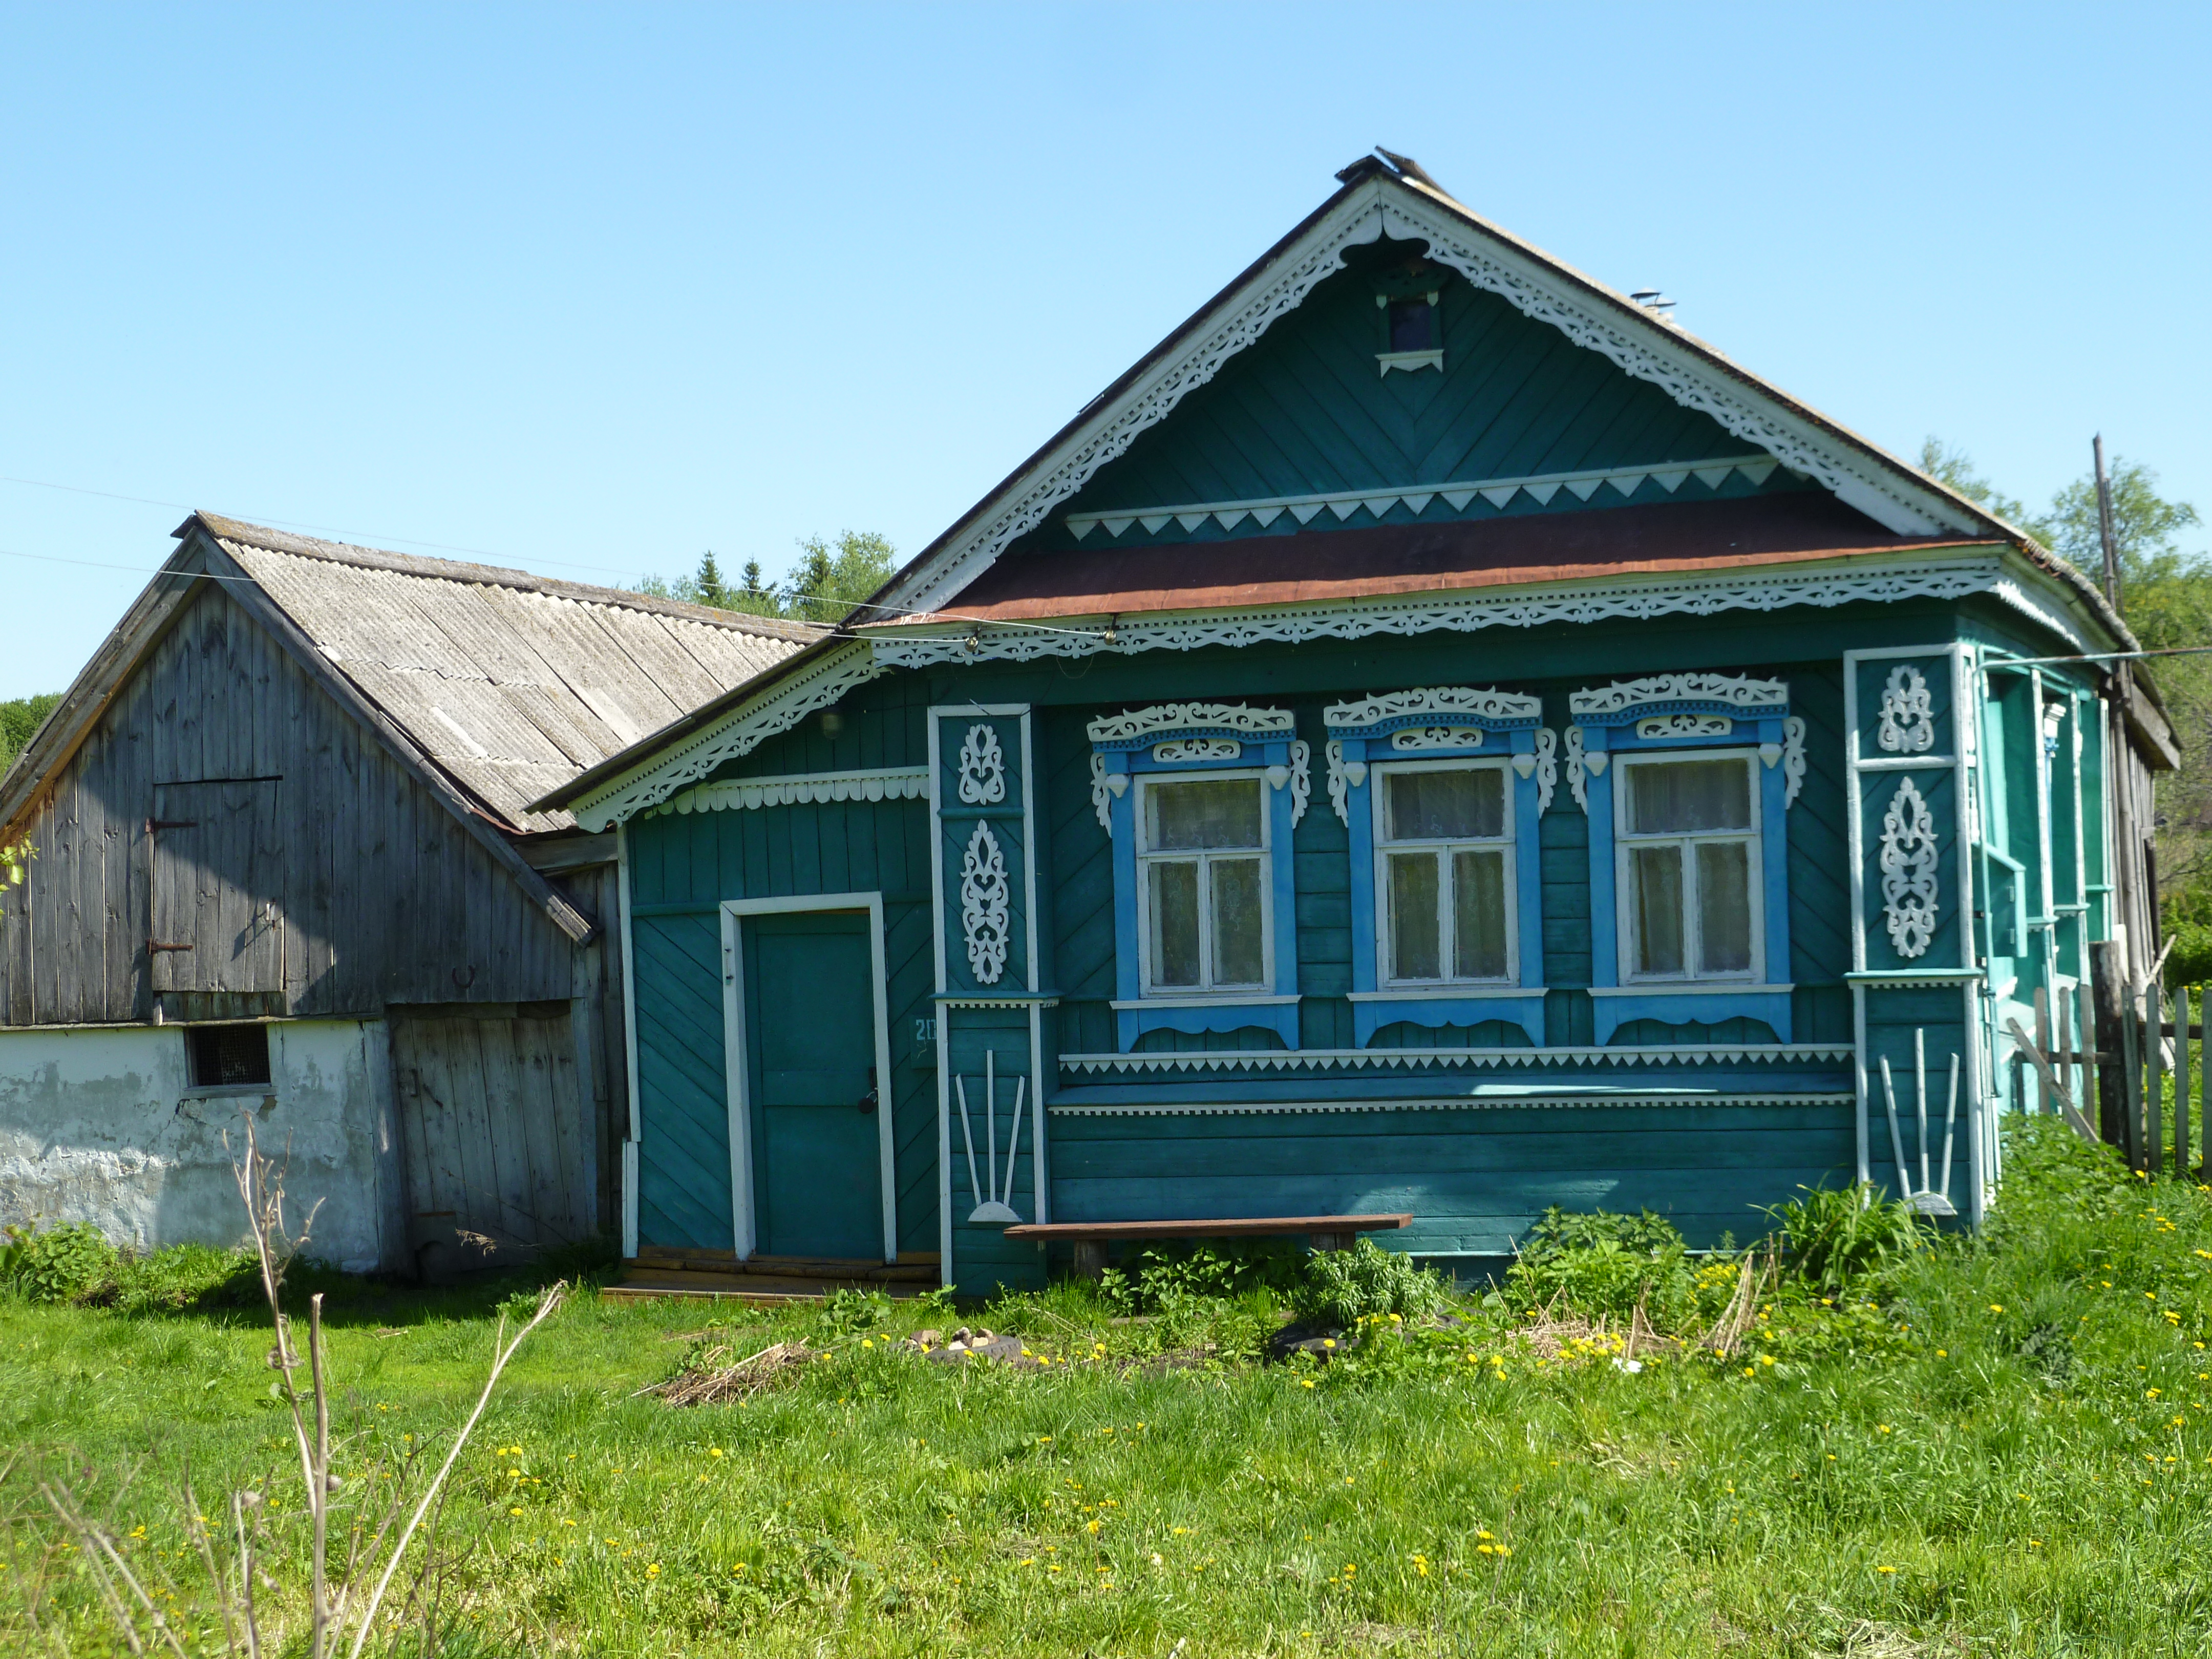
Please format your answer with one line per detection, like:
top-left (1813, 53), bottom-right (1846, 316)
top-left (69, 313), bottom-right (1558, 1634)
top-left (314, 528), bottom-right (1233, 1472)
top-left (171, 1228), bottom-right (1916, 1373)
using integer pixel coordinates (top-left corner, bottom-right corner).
top-left (743, 911), bottom-right (883, 1261)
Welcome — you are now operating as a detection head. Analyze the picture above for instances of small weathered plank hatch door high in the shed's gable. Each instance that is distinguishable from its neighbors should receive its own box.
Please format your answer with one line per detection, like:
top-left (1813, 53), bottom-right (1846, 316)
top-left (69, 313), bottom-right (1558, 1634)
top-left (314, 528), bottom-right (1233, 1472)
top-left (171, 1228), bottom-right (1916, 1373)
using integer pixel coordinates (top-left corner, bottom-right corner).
top-left (146, 779), bottom-right (283, 993)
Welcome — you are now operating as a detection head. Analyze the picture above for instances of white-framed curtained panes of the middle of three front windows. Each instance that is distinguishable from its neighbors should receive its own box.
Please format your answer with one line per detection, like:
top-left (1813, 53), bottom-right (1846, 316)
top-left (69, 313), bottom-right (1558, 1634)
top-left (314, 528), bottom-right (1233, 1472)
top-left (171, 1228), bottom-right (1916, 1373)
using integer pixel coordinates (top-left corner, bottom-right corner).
top-left (1376, 761), bottom-right (1515, 984)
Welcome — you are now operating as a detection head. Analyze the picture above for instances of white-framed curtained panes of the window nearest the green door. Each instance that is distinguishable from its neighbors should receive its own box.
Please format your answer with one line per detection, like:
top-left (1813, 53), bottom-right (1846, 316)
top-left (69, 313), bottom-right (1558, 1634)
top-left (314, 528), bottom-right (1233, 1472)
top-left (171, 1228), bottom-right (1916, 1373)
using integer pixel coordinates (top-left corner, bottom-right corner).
top-left (1137, 772), bottom-right (1274, 995)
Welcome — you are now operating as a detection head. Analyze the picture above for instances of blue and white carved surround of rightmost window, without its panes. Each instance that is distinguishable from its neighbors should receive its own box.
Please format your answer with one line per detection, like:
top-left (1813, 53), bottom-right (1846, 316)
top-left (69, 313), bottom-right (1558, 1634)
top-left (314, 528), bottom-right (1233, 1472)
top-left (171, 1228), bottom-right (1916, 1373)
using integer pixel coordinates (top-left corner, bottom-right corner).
top-left (1566, 675), bottom-right (1805, 1042)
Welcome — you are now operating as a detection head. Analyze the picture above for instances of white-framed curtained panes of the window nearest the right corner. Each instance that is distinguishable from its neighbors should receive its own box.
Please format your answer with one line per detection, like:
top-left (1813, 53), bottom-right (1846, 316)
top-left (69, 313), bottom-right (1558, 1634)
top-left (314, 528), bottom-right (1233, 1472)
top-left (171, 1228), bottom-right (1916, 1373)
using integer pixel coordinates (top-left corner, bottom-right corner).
top-left (1615, 750), bottom-right (1761, 984)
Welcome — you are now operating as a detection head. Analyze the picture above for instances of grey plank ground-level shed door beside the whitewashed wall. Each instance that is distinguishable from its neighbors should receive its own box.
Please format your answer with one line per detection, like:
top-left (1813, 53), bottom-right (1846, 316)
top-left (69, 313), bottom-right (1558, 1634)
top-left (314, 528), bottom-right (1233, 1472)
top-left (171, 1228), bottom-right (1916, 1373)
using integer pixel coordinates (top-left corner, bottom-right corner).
top-left (392, 1004), bottom-right (595, 1279)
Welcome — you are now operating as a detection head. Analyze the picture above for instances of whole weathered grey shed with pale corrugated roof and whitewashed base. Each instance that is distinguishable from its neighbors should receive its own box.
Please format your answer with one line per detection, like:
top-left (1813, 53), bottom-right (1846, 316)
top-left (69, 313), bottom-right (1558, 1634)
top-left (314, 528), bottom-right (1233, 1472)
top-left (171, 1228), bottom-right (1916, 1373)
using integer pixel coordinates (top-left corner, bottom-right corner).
top-left (0, 513), bottom-right (818, 1272)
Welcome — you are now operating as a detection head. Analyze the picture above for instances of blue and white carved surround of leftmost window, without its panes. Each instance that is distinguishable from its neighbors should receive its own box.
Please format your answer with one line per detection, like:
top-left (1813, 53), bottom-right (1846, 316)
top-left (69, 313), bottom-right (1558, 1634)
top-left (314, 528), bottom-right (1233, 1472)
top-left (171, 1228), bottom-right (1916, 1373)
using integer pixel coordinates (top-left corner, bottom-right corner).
top-left (1086, 704), bottom-right (1312, 1051)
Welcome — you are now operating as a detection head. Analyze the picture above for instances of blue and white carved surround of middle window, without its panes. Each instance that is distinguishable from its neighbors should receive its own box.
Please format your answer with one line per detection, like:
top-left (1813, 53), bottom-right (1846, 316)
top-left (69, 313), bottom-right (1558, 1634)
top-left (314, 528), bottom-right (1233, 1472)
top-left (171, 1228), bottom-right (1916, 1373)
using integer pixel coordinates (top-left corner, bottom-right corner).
top-left (1323, 686), bottom-right (1560, 1049)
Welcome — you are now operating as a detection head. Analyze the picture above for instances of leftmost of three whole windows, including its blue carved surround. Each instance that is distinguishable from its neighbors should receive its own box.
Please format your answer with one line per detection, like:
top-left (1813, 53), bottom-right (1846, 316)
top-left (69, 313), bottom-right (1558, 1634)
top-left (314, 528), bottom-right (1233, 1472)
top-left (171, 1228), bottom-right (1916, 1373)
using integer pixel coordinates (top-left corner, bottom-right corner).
top-left (1088, 704), bottom-right (1312, 1053)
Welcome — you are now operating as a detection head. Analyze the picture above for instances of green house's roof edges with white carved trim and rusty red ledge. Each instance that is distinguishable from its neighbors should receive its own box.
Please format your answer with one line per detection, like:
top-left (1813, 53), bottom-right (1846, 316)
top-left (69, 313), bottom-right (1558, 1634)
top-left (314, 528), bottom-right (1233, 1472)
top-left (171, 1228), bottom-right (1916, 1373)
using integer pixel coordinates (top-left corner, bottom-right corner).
top-left (535, 153), bottom-right (2135, 827)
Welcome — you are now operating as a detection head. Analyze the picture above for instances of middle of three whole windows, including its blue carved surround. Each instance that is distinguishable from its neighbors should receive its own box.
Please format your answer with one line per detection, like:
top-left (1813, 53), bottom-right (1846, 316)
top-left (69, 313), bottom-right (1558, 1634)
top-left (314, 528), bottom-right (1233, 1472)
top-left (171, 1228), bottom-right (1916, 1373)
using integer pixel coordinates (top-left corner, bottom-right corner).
top-left (1325, 686), bottom-right (1557, 1049)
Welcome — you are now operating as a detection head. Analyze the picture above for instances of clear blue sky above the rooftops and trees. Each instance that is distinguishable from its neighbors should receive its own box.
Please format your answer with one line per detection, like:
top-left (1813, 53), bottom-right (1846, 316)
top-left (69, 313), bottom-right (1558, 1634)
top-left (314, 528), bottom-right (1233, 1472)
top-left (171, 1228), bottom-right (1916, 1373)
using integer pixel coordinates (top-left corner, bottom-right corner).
top-left (0, 0), bottom-right (2212, 697)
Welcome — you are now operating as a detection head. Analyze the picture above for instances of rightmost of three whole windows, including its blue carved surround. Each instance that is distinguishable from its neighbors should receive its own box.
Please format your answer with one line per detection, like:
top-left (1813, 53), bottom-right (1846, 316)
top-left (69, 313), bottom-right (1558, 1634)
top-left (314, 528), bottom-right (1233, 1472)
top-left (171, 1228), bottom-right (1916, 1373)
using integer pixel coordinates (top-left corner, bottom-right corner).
top-left (1566, 675), bottom-right (1805, 1044)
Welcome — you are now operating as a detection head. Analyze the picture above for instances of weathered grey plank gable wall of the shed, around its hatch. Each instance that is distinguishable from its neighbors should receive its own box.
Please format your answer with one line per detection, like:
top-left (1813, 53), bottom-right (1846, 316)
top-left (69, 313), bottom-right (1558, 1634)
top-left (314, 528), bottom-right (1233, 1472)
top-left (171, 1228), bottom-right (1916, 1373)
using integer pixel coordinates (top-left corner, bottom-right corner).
top-left (0, 586), bottom-right (575, 1026)
